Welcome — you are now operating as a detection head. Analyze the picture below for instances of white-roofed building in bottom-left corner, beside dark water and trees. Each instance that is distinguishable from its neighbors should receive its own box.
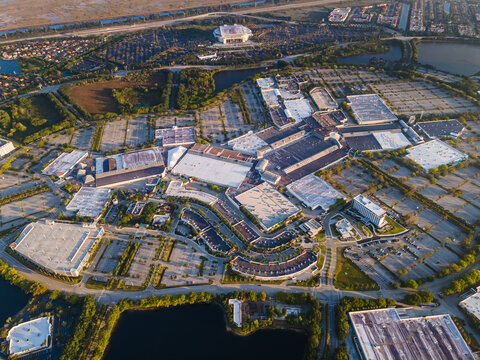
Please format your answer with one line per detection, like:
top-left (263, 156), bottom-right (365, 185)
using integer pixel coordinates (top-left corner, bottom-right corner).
top-left (7, 316), bottom-right (52, 355)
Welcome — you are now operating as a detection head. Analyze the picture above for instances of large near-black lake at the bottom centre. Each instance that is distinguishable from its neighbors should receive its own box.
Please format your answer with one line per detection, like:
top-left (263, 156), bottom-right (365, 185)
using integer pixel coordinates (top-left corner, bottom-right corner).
top-left (103, 305), bottom-right (307, 360)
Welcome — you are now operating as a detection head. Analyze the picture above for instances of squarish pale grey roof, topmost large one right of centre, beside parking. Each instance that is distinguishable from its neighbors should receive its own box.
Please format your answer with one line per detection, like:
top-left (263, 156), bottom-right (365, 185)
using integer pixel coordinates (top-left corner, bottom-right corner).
top-left (347, 94), bottom-right (397, 124)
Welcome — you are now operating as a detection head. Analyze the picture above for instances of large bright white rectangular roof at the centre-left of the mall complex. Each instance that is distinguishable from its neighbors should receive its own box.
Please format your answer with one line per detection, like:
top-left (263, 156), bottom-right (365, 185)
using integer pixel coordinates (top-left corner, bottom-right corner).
top-left (172, 150), bottom-right (252, 188)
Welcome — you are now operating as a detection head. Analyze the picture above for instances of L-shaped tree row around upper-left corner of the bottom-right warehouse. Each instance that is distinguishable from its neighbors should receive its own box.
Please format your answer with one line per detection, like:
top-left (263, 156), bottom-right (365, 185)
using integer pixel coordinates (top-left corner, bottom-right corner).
top-left (335, 296), bottom-right (396, 340)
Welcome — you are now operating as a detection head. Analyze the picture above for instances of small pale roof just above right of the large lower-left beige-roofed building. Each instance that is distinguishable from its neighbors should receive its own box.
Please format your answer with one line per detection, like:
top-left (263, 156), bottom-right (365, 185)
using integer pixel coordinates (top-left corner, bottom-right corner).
top-left (67, 187), bottom-right (110, 218)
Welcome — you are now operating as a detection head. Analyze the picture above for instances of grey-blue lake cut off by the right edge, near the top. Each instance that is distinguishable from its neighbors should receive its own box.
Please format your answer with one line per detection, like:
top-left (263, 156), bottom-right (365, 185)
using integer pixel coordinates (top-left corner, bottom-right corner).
top-left (417, 41), bottom-right (480, 75)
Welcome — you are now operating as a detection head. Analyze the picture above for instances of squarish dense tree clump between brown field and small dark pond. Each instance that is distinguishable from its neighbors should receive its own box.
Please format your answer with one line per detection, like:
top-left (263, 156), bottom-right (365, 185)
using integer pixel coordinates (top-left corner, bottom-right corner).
top-left (177, 68), bottom-right (215, 110)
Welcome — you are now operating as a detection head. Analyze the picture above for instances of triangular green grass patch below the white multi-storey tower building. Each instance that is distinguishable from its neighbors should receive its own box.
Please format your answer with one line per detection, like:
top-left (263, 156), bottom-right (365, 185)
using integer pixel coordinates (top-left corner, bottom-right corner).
top-left (333, 247), bottom-right (380, 291)
